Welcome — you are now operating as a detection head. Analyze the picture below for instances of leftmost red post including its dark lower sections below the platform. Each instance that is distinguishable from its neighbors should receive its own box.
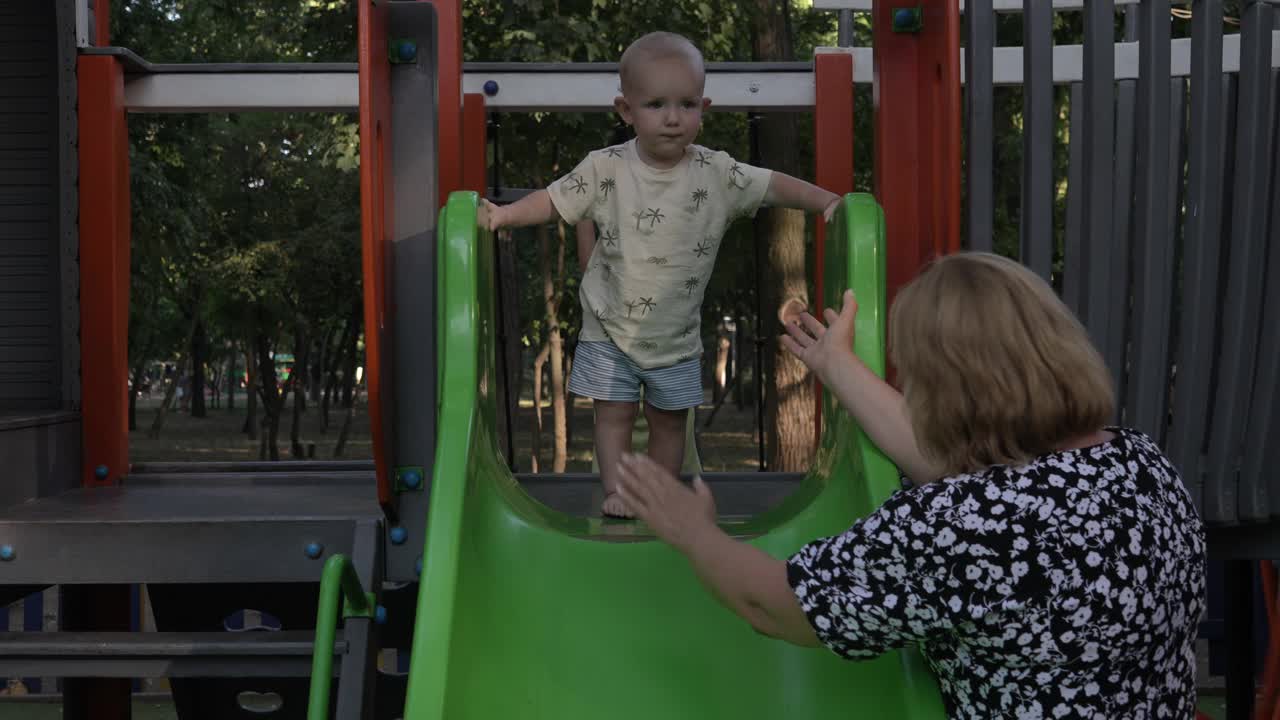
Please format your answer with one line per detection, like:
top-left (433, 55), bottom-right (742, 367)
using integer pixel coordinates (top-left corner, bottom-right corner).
top-left (70, 51), bottom-right (131, 720)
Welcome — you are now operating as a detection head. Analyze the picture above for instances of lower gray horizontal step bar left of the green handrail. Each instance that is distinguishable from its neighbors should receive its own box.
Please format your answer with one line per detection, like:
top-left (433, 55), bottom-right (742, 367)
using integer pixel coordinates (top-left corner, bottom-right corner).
top-left (0, 628), bottom-right (347, 678)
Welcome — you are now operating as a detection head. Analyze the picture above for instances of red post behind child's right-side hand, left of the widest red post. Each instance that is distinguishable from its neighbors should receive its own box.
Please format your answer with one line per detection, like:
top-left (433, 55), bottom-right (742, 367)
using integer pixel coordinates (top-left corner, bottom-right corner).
top-left (813, 53), bottom-right (854, 447)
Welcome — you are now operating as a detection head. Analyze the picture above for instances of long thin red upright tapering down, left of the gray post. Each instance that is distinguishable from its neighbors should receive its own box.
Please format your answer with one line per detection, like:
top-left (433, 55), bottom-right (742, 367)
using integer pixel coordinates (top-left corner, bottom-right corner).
top-left (357, 0), bottom-right (393, 505)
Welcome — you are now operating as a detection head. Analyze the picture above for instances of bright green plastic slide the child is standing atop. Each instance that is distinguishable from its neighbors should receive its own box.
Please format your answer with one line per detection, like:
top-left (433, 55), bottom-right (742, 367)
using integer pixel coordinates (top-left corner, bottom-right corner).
top-left (404, 193), bottom-right (943, 720)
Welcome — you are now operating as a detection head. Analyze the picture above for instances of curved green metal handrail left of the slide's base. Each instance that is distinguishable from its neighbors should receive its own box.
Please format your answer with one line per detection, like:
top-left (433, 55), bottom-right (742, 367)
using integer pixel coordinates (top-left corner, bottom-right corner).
top-left (307, 555), bottom-right (376, 720)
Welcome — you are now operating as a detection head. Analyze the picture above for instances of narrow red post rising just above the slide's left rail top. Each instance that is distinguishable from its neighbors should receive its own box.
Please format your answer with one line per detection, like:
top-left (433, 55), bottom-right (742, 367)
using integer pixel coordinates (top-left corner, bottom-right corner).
top-left (429, 0), bottom-right (465, 208)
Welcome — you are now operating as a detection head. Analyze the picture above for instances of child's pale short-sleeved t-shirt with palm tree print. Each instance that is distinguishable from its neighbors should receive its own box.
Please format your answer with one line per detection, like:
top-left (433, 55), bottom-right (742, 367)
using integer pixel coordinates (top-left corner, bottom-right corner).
top-left (547, 140), bottom-right (772, 369)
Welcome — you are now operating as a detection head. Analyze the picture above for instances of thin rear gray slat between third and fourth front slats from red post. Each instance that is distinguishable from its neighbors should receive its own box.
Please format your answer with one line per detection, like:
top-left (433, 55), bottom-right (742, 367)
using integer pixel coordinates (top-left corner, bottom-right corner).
top-left (1101, 79), bottom-right (1138, 415)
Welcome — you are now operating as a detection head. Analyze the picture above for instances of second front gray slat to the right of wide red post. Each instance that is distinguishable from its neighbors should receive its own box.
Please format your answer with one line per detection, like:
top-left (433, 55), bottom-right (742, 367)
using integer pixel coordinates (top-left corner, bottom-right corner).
top-left (1020, 3), bottom-right (1055, 281)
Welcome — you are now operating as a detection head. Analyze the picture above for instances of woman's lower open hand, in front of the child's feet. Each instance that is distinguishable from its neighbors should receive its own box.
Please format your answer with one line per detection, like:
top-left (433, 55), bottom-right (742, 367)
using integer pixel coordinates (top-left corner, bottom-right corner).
top-left (618, 455), bottom-right (717, 552)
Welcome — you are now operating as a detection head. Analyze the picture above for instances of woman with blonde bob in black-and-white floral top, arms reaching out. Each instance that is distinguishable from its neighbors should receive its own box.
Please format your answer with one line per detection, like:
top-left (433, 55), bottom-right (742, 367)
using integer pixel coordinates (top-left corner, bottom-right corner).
top-left (621, 252), bottom-right (1204, 719)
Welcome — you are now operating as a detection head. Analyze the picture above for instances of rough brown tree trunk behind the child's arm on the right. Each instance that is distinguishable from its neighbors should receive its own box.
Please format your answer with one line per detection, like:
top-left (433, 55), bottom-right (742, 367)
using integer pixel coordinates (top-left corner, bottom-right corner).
top-left (751, 0), bottom-right (814, 471)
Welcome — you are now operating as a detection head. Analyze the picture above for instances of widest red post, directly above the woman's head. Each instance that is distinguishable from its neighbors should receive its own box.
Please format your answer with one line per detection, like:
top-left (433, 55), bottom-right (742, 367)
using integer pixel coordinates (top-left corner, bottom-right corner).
top-left (872, 0), bottom-right (961, 313)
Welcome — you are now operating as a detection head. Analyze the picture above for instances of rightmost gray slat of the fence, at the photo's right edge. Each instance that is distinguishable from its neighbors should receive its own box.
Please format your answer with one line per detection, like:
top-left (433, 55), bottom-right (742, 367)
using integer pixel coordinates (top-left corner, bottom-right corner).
top-left (1206, 3), bottom-right (1272, 521)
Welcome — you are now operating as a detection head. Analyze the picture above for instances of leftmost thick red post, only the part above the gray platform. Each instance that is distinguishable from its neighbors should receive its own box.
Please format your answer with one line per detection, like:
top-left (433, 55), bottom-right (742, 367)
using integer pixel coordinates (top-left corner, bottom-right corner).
top-left (77, 55), bottom-right (129, 486)
